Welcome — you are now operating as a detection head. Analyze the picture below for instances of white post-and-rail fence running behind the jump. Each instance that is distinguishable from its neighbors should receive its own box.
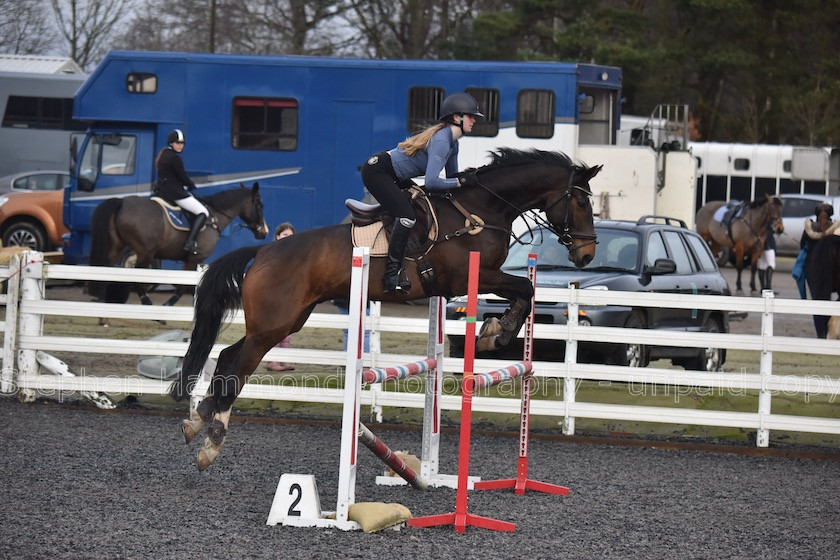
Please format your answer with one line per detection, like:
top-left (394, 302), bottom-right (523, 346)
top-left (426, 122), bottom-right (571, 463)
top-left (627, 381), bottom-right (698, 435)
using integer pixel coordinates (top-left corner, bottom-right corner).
top-left (0, 252), bottom-right (840, 447)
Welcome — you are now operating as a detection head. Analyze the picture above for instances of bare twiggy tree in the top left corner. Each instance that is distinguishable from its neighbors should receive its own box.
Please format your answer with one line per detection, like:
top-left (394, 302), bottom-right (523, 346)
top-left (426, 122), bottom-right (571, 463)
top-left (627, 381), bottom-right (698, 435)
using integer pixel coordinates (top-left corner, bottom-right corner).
top-left (0, 0), bottom-right (56, 54)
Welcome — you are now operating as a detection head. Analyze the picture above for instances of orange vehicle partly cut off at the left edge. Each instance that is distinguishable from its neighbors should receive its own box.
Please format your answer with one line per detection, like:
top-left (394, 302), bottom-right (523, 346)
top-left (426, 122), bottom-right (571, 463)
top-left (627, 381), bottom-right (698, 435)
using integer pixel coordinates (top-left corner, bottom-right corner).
top-left (0, 189), bottom-right (70, 252)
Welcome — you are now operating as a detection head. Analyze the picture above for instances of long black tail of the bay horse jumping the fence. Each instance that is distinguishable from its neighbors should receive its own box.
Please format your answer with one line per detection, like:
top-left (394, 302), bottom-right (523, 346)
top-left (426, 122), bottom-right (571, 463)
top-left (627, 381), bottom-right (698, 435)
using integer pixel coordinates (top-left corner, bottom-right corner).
top-left (169, 245), bottom-right (260, 401)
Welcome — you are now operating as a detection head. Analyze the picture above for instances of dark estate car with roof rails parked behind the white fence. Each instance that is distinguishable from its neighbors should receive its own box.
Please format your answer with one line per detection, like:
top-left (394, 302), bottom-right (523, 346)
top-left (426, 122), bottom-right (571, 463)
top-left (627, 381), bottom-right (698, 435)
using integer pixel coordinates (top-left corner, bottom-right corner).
top-left (446, 216), bottom-right (730, 371)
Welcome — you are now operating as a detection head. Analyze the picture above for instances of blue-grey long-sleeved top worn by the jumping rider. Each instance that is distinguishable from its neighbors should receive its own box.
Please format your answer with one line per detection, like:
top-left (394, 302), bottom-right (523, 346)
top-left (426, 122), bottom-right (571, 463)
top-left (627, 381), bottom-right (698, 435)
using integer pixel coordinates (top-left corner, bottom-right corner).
top-left (388, 126), bottom-right (458, 190)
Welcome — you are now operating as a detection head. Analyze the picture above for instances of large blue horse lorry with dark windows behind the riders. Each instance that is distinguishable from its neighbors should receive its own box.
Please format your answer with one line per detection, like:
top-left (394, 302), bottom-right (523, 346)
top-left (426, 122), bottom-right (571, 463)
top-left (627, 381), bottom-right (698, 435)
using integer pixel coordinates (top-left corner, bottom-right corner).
top-left (64, 51), bottom-right (691, 264)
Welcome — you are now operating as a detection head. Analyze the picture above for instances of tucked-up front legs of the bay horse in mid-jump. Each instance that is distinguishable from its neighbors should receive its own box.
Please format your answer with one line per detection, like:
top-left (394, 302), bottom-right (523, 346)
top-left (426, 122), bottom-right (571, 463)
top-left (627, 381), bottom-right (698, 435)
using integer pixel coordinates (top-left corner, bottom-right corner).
top-left (475, 270), bottom-right (534, 352)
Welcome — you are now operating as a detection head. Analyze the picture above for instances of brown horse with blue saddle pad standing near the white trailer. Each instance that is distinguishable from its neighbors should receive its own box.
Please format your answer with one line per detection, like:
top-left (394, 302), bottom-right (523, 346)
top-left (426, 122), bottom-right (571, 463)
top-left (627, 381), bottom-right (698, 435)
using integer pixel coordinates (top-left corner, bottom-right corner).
top-left (694, 195), bottom-right (785, 295)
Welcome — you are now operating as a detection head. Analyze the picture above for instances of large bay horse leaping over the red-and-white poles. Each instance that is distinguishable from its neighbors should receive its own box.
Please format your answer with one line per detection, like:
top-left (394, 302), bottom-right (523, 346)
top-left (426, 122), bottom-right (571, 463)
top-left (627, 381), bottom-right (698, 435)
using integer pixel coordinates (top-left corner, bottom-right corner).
top-left (170, 148), bottom-right (602, 470)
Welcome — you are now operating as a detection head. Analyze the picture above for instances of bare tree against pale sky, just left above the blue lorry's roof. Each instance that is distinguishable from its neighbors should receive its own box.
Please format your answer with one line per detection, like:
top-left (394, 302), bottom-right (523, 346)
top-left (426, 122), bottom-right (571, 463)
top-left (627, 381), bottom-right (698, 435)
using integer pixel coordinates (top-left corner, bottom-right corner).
top-left (50, 0), bottom-right (132, 69)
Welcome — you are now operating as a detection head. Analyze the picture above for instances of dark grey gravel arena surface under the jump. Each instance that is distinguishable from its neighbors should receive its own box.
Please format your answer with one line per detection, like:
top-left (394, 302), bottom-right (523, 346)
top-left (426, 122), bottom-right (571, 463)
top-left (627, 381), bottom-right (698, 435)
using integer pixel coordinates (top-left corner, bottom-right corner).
top-left (0, 398), bottom-right (840, 560)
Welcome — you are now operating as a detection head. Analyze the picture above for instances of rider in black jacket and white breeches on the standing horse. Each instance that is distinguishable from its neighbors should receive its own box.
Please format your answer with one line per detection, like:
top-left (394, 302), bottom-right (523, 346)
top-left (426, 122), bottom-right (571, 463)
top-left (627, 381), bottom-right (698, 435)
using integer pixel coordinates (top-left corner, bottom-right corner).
top-left (154, 128), bottom-right (210, 255)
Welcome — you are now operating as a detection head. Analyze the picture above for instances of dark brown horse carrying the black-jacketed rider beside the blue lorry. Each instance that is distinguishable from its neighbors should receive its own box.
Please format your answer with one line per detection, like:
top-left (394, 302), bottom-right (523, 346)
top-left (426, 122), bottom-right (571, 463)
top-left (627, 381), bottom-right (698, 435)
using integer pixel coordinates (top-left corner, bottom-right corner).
top-left (88, 183), bottom-right (268, 305)
